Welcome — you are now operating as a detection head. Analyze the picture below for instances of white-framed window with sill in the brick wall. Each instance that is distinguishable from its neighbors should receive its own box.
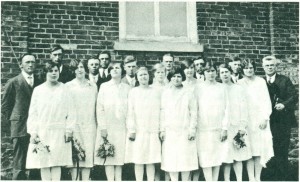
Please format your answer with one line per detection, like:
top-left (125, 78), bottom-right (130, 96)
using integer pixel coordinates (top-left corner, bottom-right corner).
top-left (115, 1), bottom-right (202, 52)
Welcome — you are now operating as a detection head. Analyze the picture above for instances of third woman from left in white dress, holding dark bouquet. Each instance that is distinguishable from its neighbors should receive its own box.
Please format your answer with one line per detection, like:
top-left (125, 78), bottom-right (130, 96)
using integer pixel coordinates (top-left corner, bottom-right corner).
top-left (94, 63), bottom-right (130, 181)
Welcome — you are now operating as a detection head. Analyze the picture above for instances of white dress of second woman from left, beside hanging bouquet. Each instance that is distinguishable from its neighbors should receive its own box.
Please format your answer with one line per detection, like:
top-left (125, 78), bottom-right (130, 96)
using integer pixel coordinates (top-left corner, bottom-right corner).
top-left (66, 79), bottom-right (98, 168)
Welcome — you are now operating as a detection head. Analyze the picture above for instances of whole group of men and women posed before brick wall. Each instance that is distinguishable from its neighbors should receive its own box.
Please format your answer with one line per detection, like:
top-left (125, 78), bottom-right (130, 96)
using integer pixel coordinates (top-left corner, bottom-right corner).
top-left (2, 46), bottom-right (297, 181)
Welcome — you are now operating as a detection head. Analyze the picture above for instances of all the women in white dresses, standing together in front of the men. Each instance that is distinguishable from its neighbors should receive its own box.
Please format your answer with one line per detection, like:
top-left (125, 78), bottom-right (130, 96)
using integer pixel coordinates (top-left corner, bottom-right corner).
top-left (26, 61), bottom-right (273, 181)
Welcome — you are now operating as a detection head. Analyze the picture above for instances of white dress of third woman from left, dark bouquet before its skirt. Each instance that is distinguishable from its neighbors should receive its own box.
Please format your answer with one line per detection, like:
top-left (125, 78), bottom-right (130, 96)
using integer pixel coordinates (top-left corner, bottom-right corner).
top-left (94, 80), bottom-right (130, 165)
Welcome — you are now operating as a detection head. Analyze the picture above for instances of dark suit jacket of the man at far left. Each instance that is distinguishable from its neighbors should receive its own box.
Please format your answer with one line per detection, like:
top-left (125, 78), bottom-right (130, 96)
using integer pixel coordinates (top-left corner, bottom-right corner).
top-left (1, 73), bottom-right (42, 137)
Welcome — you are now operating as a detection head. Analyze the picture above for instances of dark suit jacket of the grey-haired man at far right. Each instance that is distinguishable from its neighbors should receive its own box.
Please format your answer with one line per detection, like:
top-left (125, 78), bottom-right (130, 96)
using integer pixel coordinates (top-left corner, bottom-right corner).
top-left (264, 74), bottom-right (298, 125)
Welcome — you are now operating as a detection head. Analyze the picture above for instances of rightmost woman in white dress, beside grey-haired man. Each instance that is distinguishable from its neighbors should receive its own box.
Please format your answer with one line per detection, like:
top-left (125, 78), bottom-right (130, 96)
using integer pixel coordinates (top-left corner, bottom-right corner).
top-left (238, 60), bottom-right (274, 181)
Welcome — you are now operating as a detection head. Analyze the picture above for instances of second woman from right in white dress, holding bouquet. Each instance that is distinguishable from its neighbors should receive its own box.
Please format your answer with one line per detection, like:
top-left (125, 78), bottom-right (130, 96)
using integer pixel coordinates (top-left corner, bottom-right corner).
top-left (219, 63), bottom-right (252, 181)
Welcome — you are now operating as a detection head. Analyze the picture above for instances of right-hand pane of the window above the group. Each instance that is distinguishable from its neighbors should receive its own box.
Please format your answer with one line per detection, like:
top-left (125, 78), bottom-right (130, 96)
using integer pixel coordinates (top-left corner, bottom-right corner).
top-left (159, 2), bottom-right (187, 36)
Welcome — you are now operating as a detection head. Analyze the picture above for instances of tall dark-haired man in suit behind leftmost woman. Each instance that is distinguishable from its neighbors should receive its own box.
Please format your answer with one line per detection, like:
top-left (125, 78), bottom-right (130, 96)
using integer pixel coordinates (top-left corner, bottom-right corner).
top-left (50, 45), bottom-right (75, 83)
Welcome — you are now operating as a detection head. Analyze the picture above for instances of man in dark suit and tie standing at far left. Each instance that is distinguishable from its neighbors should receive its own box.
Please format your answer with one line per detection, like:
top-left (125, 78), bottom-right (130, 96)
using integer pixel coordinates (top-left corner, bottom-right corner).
top-left (1, 54), bottom-right (41, 180)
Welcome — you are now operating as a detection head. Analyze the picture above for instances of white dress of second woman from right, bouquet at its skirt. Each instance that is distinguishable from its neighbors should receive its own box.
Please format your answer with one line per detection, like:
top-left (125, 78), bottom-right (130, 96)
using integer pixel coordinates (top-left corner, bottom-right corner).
top-left (224, 84), bottom-right (252, 163)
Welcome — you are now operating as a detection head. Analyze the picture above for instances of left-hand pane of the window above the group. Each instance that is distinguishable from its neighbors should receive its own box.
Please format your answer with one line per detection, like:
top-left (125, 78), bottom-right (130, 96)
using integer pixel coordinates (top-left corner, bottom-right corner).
top-left (126, 2), bottom-right (154, 36)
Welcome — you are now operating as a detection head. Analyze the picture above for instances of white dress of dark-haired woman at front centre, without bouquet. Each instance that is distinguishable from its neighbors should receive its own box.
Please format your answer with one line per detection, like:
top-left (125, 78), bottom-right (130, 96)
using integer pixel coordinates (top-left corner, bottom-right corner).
top-left (160, 87), bottom-right (198, 172)
